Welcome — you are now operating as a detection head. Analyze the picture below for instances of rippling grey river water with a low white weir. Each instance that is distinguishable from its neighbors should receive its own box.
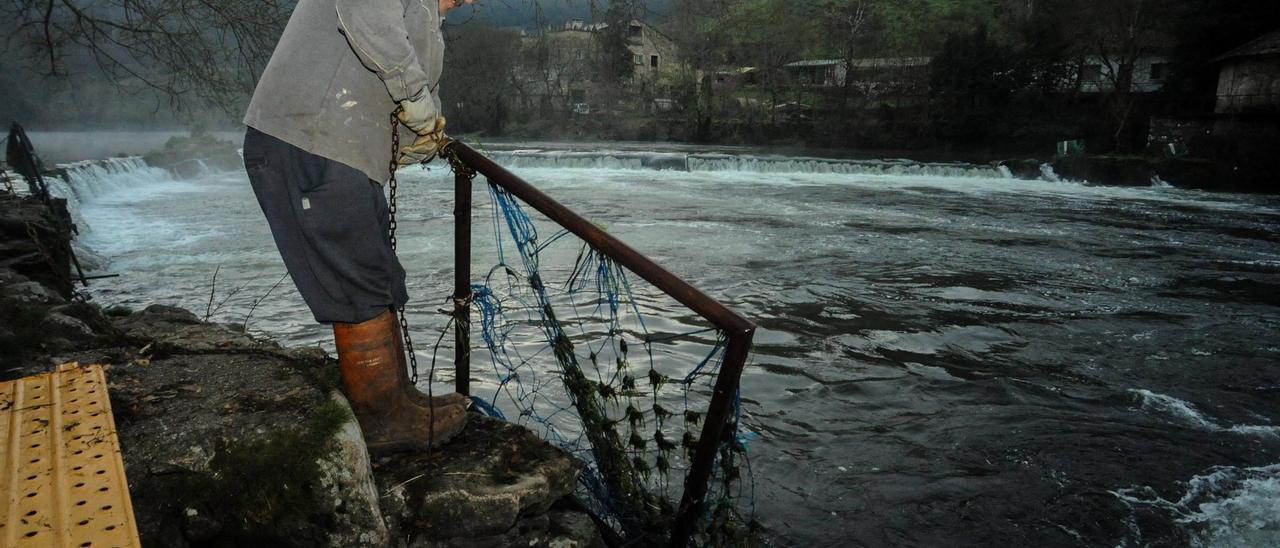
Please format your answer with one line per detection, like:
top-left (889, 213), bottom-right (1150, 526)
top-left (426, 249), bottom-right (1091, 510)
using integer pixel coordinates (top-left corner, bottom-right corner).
top-left (37, 135), bottom-right (1280, 545)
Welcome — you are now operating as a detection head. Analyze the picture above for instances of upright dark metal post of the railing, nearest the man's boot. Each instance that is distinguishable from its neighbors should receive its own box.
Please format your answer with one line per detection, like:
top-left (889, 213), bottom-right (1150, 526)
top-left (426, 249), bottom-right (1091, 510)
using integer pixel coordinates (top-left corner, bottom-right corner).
top-left (453, 169), bottom-right (474, 396)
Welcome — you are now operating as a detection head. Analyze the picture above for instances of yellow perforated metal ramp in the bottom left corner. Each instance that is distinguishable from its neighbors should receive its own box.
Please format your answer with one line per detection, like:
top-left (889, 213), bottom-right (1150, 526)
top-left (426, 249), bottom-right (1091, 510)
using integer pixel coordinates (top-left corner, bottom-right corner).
top-left (0, 364), bottom-right (138, 547)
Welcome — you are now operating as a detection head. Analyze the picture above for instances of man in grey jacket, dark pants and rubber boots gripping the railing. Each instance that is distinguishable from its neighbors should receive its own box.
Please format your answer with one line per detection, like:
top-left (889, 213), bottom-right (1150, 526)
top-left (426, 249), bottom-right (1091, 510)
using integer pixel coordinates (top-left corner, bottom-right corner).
top-left (244, 0), bottom-right (474, 453)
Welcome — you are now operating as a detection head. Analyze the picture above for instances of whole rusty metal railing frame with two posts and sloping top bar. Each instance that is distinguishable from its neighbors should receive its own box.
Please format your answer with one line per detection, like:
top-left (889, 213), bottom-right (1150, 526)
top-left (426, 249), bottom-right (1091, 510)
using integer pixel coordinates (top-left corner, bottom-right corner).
top-left (444, 141), bottom-right (755, 547)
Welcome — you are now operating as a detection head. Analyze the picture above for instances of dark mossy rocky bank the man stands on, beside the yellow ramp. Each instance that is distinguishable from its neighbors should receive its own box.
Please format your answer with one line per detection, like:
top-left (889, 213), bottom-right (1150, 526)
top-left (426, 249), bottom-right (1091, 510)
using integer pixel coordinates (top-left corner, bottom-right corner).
top-left (0, 205), bottom-right (603, 547)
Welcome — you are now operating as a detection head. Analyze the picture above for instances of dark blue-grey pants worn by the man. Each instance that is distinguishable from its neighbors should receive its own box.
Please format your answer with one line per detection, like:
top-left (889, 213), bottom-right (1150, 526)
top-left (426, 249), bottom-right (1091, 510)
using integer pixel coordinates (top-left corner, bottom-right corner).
top-left (244, 128), bottom-right (408, 323)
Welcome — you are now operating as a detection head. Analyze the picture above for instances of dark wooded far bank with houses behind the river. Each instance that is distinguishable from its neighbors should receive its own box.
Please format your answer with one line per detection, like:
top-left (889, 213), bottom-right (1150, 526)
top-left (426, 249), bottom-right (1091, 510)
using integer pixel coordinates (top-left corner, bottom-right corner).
top-left (0, 0), bottom-right (1280, 171)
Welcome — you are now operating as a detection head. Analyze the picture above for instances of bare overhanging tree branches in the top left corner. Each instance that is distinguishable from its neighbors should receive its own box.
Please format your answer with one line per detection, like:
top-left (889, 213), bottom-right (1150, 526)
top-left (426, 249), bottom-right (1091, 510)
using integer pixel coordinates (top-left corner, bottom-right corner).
top-left (0, 0), bottom-right (293, 110)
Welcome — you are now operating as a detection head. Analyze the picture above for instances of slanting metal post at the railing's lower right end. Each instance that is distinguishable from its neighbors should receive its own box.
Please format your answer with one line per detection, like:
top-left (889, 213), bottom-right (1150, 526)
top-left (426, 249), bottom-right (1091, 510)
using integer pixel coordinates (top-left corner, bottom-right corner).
top-left (669, 328), bottom-right (755, 548)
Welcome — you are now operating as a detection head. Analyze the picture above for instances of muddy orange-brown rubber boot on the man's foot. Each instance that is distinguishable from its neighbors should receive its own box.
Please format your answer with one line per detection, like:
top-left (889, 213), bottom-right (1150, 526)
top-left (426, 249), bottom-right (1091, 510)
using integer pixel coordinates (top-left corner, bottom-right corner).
top-left (333, 310), bottom-right (467, 455)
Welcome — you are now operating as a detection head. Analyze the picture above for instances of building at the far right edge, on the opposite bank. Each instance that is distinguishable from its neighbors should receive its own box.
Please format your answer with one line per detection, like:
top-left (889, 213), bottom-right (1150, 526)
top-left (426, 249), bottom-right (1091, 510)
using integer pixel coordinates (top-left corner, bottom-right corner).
top-left (1215, 29), bottom-right (1280, 114)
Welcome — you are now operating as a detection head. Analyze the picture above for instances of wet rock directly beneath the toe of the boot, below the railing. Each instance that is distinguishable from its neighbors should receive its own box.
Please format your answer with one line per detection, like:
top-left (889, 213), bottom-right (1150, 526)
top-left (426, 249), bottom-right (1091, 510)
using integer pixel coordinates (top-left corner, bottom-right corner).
top-left (375, 416), bottom-right (581, 545)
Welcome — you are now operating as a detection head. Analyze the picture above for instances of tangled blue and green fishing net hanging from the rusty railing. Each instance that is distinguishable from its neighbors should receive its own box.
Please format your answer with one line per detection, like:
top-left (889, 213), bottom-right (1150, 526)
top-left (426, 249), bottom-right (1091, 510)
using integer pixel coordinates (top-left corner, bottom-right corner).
top-left (430, 160), bottom-right (755, 545)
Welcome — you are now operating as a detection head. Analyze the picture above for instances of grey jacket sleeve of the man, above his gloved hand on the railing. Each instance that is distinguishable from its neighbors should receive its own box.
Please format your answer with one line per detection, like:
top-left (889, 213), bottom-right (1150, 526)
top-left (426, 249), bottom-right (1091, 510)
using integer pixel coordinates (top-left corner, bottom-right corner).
top-left (337, 0), bottom-right (428, 102)
